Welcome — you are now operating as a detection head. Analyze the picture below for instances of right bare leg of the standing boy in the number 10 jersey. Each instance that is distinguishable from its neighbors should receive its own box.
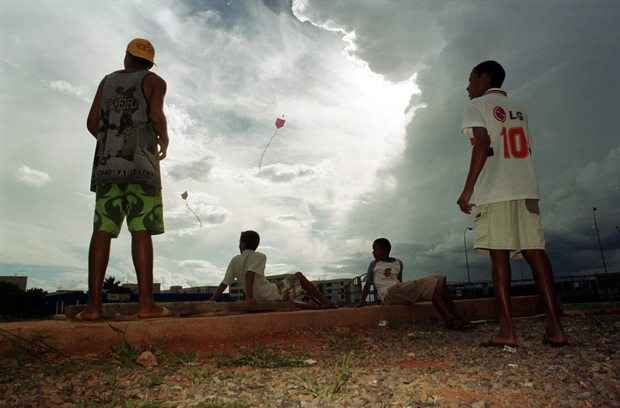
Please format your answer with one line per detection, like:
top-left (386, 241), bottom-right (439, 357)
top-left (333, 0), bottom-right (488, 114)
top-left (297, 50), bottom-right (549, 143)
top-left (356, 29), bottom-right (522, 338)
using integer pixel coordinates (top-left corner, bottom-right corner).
top-left (522, 249), bottom-right (567, 344)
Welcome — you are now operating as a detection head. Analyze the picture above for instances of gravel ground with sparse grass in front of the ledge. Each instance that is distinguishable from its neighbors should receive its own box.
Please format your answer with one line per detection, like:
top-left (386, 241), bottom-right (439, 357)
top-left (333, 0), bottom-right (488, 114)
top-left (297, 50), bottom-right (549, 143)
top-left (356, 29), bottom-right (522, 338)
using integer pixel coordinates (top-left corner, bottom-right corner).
top-left (0, 315), bottom-right (620, 408)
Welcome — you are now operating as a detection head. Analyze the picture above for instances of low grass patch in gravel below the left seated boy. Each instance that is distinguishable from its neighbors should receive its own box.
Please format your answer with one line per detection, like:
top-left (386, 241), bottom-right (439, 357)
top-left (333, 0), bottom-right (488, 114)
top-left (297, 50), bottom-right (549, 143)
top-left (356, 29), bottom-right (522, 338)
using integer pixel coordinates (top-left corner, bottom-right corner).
top-left (217, 346), bottom-right (306, 368)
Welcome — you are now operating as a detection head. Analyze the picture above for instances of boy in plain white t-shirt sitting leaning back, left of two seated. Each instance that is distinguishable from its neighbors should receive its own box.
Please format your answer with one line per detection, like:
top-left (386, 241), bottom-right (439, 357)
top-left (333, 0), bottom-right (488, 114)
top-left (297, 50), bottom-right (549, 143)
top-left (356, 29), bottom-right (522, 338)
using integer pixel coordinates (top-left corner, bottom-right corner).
top-left (212, 231), bottom-right (332, 307)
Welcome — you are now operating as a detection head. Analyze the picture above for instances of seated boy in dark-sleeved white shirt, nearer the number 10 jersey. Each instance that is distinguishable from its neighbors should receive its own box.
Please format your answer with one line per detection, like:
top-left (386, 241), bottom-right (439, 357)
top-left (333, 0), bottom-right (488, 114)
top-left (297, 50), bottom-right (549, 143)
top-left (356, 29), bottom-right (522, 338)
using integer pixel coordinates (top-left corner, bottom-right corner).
top-left (361, 238), bottom-right (465, 329)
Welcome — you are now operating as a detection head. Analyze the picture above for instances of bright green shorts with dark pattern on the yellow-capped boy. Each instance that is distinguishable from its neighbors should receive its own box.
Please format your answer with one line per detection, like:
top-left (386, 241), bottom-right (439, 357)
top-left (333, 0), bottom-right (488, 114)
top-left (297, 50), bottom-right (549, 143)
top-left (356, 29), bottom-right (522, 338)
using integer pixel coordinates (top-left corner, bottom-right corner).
top-left (94, 183), bottom-right (164, 238)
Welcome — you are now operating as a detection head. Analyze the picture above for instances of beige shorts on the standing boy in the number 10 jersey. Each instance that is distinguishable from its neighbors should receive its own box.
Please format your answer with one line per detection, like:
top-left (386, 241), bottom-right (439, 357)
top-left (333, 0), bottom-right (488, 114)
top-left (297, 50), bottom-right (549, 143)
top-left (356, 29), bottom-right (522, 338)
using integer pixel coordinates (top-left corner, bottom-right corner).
top-left (474, 199), bottom-right (545, 256)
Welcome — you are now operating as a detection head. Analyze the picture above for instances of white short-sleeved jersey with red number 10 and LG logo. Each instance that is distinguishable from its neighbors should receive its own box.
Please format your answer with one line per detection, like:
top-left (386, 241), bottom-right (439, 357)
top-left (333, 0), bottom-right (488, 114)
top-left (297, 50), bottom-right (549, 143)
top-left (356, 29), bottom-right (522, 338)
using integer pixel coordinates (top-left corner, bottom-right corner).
top-left (462, 88), bottom-right (538, 205)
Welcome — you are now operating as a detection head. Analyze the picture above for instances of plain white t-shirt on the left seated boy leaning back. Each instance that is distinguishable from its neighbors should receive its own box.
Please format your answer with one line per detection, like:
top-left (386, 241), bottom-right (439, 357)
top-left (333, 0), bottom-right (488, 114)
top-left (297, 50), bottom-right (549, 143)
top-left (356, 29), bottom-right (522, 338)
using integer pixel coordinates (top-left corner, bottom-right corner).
top-left (222, 249), bottom-right (282, 300)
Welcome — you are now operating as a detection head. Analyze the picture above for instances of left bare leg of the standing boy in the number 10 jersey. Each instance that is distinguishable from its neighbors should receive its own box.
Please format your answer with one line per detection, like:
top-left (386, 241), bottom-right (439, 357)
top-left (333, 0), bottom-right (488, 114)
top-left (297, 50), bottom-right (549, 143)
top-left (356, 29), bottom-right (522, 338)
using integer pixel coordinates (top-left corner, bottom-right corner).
top-left (490, 250), bottom-right (517, 346)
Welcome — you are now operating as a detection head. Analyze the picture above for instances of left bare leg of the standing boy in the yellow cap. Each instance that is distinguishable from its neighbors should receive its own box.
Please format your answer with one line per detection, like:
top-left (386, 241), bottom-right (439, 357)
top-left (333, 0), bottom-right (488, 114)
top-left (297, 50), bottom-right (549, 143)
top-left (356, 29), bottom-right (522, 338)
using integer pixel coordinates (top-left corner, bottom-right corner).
top-left (78, 231), bottom-right (112, 320)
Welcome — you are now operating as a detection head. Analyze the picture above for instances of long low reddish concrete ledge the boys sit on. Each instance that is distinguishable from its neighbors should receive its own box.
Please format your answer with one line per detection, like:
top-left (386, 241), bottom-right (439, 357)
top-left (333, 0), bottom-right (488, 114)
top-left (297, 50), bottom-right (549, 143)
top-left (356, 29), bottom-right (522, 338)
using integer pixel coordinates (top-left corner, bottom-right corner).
top-left (0, 296), bottom-right (541, 354)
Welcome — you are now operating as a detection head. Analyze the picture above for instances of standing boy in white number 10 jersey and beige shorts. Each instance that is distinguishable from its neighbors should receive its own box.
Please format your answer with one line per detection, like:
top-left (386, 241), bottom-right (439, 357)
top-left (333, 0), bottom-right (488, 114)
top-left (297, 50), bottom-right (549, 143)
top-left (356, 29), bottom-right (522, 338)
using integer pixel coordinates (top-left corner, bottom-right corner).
top-left (458, 61), bottom-right (567, 347)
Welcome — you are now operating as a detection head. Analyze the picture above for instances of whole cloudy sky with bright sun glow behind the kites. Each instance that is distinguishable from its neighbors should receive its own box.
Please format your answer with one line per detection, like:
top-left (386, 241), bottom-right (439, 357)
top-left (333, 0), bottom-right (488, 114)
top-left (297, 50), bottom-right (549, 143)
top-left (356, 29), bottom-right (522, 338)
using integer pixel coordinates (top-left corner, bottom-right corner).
top-left (0, 0), bottom-right (620, 290)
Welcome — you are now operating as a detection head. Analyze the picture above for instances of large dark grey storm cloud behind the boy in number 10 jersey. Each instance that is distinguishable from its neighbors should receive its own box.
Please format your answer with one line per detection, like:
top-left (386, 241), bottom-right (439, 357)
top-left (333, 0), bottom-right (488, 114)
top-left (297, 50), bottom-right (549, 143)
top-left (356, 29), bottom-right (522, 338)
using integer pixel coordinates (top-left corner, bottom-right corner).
top-left (302, 0), bottom-right (620, 279)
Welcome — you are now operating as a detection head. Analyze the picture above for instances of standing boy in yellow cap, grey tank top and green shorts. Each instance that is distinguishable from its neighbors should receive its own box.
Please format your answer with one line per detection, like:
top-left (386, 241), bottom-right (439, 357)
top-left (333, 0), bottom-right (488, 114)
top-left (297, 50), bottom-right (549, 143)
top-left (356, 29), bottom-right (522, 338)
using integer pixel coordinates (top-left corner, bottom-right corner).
top-left (78, 38), bottom-right (170, 320)
